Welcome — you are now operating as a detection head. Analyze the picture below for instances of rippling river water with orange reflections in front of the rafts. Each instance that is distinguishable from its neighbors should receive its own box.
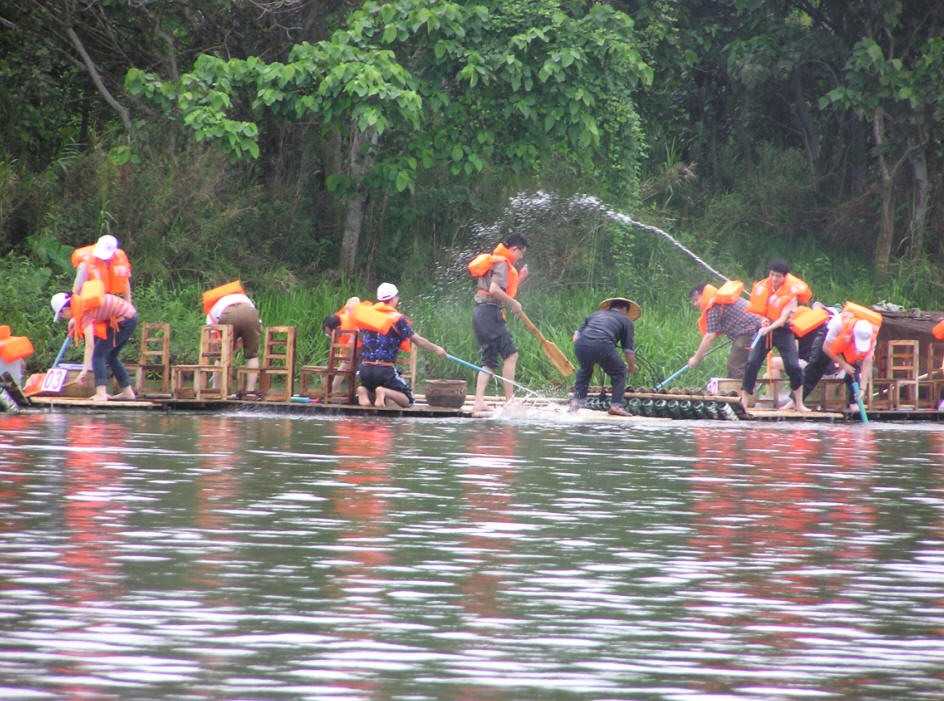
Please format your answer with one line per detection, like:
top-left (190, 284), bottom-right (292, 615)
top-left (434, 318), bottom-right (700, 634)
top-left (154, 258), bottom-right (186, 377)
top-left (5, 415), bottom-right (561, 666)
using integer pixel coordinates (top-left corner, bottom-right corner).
top-left (0, 412), bottom-right (944, 701)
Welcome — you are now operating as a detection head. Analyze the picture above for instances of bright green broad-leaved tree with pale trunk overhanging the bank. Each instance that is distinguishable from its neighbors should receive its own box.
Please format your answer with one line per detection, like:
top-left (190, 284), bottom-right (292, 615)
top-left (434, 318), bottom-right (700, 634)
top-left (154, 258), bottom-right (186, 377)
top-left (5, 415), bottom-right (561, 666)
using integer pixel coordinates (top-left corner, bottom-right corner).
top-left (126, 0), bottom-right (652, 273)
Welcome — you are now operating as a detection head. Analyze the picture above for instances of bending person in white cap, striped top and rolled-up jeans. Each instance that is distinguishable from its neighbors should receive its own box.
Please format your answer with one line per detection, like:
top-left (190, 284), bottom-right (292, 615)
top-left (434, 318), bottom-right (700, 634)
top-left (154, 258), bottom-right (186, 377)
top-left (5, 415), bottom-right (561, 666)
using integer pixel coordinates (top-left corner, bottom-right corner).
top-left (51, 292), bottom-right (138, 402)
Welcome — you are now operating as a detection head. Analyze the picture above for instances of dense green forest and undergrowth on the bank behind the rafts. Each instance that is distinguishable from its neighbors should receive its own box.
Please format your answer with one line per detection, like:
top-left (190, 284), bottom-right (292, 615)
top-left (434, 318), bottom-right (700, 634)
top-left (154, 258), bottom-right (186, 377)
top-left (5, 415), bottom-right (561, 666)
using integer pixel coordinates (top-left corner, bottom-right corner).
top-left (0, 0), bottom-right (944, 382)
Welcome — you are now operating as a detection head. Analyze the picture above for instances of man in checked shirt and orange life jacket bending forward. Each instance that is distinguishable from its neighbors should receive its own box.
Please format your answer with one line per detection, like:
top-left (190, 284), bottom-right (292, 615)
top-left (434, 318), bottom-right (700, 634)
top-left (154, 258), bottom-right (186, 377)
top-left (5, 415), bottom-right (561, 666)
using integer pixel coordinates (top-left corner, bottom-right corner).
top-left (688, 283), bottom-right (761, 380)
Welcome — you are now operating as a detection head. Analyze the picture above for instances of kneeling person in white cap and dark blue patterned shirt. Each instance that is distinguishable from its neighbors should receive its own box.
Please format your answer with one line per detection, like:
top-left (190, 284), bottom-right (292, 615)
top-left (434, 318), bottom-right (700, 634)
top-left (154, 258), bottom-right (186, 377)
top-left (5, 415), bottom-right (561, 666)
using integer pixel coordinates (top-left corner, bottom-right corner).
top-left (357, 282), bottom-right (447, 407)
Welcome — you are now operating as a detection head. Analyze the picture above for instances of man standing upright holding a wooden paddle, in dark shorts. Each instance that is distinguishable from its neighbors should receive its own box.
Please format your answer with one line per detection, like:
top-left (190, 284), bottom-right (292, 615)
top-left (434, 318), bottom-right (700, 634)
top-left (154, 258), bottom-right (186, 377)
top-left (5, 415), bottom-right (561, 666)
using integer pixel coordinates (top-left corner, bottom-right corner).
top-left (472, 233), bottom-right (529, 411)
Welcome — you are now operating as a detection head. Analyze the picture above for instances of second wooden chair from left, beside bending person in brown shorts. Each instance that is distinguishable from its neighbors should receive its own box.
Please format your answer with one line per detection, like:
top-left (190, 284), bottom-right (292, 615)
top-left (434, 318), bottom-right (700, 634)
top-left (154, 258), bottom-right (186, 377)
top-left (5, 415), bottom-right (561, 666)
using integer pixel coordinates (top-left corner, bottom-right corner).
top-left (171, 324), bottom-right (233, 399)
